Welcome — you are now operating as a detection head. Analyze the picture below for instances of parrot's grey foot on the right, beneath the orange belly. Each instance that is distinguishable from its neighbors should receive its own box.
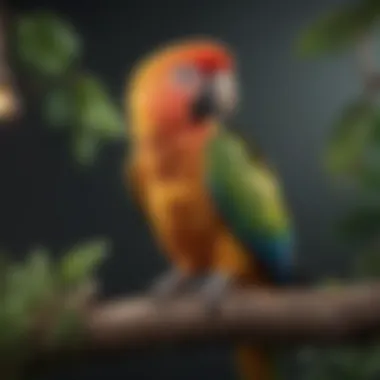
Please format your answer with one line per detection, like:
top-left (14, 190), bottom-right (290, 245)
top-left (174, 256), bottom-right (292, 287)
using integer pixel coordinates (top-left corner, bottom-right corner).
top-left (201, 273), bottom-right (232, 314)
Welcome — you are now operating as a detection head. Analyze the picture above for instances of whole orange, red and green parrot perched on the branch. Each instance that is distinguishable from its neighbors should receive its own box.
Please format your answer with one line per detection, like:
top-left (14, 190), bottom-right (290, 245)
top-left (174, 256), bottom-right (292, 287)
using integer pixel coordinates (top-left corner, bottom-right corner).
top-left (123, 38), bottom-right (294, 380)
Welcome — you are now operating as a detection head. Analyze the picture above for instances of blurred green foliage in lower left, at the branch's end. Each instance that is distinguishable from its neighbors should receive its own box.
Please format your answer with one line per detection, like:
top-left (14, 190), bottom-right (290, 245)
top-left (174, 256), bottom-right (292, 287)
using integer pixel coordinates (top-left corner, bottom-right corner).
top-left (0, 240), bottom-right (106, 373)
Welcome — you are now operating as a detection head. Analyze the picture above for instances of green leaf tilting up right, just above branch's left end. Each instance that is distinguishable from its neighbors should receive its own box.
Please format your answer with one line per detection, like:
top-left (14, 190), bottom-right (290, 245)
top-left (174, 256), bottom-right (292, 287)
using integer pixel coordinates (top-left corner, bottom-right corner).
top-left (60, 240), bottom-right (107, 286)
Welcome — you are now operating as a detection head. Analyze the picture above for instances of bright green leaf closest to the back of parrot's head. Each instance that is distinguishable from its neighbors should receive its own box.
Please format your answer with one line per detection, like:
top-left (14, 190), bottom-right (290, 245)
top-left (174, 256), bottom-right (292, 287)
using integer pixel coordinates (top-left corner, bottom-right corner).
top-left (71, 74), bottom-right (124, 138)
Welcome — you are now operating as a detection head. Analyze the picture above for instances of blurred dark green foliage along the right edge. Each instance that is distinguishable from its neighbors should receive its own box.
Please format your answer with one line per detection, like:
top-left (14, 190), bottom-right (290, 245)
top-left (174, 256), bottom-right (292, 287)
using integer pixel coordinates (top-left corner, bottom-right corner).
top-left (296, 0), bottom-right (380, 380)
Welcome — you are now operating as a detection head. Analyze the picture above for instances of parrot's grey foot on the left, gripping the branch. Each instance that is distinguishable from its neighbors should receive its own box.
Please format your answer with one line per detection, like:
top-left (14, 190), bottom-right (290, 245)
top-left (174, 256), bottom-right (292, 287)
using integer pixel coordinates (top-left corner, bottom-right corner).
top-left (151, 269), bottom-right (190, 301)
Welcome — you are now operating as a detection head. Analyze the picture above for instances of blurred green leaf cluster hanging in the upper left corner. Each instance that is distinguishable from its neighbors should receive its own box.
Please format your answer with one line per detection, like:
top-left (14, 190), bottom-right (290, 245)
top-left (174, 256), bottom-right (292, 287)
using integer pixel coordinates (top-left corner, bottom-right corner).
top-left (13, 11), bottom-right (123, 165)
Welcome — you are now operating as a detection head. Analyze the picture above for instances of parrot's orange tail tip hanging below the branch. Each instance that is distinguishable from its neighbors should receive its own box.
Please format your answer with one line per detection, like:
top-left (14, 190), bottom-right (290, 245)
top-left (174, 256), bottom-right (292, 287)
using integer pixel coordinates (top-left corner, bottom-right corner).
top-left (236, 346), bottom-right (275, 380)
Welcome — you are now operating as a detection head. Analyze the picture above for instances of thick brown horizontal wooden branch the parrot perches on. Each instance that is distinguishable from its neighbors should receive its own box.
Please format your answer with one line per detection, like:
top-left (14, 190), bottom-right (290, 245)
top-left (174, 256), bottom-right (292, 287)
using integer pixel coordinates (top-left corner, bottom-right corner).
top-left (29, 283), bottom-right (380, 368)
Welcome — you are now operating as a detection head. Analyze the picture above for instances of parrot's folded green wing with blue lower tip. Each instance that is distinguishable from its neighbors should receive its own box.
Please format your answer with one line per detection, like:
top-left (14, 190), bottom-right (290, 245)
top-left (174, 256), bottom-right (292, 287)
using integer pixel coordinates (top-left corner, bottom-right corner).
top-left (206, 131), bottom-right (294, 282)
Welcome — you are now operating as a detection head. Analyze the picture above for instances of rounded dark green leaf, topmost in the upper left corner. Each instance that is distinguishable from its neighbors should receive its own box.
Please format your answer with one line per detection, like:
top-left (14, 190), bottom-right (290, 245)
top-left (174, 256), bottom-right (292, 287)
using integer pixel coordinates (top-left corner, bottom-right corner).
top-left (16, 11), bottom-right (81, 77)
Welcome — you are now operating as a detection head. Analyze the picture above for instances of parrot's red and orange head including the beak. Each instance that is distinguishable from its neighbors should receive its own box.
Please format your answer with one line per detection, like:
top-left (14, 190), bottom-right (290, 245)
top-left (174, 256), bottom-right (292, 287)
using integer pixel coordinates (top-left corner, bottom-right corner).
top-left (127, 39), bottom-right (237, 142)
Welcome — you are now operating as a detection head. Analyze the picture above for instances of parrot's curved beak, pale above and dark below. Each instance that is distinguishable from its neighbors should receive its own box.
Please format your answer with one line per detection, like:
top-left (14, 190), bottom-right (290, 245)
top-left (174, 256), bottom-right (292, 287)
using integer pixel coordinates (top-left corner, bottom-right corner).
top-left (192, 74), bottom-right (237, 121)
